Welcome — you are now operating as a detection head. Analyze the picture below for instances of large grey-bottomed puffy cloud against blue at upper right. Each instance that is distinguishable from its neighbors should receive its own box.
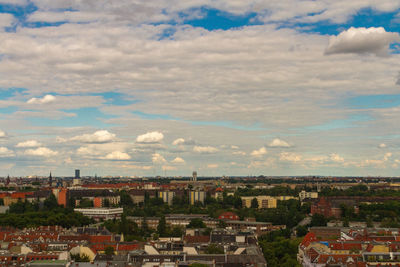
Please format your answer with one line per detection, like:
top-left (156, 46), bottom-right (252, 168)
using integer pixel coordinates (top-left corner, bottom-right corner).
top-left (325, 27), bottom-right (400, 56)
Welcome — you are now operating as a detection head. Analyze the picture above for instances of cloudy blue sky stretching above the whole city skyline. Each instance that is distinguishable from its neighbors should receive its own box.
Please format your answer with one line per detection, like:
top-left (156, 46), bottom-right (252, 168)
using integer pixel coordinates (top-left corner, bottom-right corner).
top-left (0, 0), bottom-right (400, 176)
